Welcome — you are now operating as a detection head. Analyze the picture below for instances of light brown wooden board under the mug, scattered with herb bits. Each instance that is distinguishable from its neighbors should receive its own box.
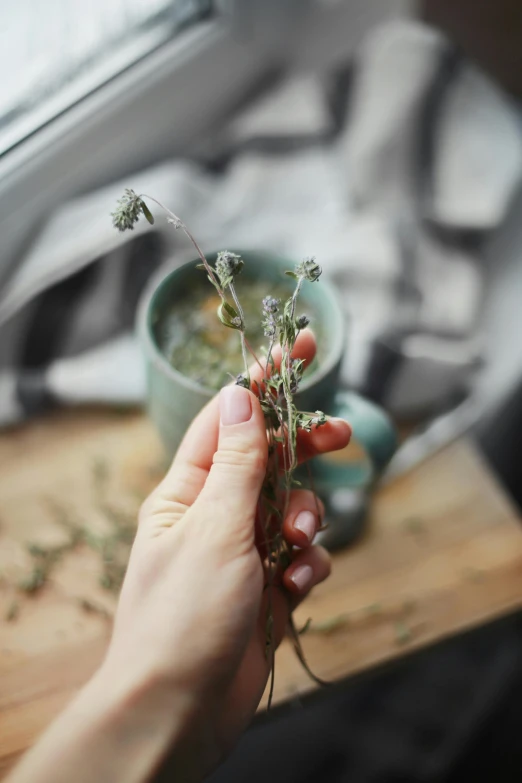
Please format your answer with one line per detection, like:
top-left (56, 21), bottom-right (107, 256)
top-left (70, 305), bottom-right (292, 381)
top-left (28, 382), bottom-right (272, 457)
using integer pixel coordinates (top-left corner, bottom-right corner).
top-left (0, 411), bottom-right (522, 776)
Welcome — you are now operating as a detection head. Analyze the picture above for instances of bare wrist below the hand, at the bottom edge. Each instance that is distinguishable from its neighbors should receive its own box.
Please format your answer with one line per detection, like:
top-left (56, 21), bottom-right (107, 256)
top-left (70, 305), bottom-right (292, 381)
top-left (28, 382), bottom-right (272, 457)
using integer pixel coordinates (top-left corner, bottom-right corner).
top-left (10, 665), bottom-right (201, 783)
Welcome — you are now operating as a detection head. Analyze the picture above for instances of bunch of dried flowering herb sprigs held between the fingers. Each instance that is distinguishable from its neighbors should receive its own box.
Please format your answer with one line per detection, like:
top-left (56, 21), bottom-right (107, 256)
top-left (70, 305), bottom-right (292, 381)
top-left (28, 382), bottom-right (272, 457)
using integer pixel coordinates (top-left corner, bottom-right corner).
top-left (112, 189), bottom-right (326, 706)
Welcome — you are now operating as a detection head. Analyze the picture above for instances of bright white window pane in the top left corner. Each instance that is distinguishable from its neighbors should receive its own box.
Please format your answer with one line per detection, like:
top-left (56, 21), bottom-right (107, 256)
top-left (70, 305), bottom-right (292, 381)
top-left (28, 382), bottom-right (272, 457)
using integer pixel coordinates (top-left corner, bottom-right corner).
top-left (0, 0), bottom-right (209, 154)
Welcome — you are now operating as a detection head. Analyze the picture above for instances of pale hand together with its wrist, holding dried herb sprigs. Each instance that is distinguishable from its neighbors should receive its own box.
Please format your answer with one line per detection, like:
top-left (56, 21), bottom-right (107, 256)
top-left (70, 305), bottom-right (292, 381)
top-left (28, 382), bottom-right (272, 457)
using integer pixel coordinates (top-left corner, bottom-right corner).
top-left (9, 331), bottom-right (350, 783)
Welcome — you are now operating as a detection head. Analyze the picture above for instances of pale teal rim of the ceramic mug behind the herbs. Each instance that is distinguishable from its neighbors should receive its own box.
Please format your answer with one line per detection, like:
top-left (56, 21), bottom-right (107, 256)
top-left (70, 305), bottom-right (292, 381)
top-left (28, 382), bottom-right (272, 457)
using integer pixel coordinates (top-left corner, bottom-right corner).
top-left (137, 249), bottom-right (345, 399)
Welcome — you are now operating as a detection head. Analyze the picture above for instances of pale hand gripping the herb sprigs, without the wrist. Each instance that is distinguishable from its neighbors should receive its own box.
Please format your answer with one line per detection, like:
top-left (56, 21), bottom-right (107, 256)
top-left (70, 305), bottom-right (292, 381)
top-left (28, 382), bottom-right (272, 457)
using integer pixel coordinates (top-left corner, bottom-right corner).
top-left (98, 331), bottom-right (350, 779)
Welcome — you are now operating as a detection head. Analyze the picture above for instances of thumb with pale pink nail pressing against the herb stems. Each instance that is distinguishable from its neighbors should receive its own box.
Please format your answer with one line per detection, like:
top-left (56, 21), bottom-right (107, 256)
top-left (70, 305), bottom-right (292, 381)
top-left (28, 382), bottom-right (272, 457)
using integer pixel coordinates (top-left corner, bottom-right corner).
top-left (195, 386), bottom-right (268, 539)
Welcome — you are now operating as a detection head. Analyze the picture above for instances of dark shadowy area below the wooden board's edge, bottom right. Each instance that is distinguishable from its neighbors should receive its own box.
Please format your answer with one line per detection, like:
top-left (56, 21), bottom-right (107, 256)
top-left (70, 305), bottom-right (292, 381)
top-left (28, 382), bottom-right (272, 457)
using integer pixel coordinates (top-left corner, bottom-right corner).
top-left (201, 617), bottom-right (522, 783)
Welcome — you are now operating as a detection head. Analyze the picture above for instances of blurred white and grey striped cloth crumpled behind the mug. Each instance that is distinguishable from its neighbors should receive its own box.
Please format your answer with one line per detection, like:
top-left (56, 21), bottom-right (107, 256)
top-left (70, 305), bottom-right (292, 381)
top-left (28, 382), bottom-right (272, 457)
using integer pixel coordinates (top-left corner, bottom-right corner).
top-left (0, 23), bottom-right (512, 426)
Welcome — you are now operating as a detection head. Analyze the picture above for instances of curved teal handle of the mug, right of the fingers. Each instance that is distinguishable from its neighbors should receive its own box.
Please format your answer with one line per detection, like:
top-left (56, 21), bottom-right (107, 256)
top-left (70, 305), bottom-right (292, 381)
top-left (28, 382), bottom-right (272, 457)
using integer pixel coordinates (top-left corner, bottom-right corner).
top-left (311, 390), bottom-right (398, 492)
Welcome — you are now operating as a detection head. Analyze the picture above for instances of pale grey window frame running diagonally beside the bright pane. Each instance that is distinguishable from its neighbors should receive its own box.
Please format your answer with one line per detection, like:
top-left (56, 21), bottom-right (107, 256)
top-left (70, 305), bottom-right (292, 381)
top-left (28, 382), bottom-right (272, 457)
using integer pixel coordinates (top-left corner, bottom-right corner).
top-left (0, 0), bottom-right (413, 285)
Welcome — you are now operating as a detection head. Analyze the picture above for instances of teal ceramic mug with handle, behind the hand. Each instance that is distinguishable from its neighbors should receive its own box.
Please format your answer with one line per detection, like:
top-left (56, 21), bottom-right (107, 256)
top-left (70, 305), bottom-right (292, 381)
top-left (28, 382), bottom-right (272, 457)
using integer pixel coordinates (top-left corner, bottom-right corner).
top-left (138, 251), bottom-right (396, 548)
